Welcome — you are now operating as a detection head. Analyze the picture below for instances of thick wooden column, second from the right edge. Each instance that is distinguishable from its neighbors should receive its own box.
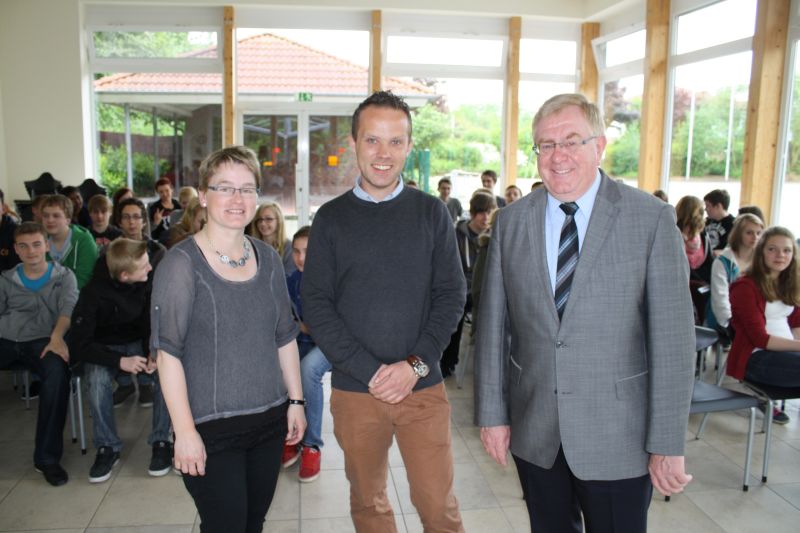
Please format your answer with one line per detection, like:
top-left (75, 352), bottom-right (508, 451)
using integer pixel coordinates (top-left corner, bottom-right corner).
top-left (639, 0), bottom-right (670, 192)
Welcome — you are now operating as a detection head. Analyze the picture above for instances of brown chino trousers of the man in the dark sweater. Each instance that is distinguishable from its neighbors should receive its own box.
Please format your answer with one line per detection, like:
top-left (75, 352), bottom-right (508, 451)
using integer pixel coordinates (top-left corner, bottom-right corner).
top-left (331, 383), bottom-right (464, 533)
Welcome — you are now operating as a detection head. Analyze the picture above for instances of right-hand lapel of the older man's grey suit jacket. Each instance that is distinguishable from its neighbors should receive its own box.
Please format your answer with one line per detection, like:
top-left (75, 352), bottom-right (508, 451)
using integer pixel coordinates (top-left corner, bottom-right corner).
top-left (553, 170), bottom-right (621, 323)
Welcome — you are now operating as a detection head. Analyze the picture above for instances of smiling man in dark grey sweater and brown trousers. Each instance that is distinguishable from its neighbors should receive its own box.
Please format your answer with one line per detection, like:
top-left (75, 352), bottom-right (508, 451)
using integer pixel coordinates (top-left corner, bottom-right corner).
top-left (301, 92), bottom-right (466, 533)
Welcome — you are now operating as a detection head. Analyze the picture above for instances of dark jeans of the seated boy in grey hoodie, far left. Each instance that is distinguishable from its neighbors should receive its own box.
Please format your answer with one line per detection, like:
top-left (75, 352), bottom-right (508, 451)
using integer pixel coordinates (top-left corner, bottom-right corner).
top-left (0, 338), bottom-right (69, 465)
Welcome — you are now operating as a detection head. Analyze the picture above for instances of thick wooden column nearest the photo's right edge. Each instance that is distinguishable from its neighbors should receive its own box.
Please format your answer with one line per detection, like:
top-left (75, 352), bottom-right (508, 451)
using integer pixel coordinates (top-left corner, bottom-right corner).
top-left (741, 0), bottom-right (790, 223)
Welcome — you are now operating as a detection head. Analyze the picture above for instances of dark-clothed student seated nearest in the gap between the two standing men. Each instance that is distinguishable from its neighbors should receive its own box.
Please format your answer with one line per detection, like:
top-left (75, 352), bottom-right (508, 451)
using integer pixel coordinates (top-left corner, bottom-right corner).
top-left (439, 189), bottom-right (497, 377)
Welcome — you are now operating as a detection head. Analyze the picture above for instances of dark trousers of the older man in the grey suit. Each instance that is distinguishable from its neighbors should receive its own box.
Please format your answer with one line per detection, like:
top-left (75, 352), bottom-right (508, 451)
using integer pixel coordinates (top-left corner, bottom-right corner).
top-left (514, 449), bottom-right (653, 533)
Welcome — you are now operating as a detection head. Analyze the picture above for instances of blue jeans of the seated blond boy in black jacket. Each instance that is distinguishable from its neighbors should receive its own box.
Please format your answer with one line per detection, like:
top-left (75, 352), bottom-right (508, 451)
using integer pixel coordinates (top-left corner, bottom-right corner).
top-left (83, 342), bottom-right (170, 452)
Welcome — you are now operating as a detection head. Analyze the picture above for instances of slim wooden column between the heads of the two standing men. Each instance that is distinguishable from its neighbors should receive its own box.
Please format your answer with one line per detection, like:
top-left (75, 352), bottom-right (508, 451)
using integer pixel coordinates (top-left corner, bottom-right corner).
top-left (501, 17), bottom-right (522, 186)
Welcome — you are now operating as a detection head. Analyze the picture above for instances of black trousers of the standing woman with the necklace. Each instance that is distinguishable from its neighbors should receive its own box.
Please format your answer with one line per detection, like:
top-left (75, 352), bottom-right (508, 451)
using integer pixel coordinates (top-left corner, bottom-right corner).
top-left (183, 435), bottom-right (284, 533)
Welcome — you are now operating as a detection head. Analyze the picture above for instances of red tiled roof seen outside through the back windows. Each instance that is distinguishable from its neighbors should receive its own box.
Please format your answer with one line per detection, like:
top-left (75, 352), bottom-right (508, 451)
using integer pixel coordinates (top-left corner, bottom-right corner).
top-left (94, 33), bottom-right (435, 96)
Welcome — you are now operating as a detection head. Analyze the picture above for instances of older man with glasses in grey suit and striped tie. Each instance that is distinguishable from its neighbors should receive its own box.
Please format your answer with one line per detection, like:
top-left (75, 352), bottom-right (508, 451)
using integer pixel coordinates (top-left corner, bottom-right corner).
top-left (475, 94), bottom-right (694, 533)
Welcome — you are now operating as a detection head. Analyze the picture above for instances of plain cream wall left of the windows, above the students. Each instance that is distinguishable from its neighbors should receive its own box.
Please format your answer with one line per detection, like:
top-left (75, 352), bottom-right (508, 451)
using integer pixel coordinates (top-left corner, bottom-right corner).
top-left (0, 0), bottom-right (86, 201)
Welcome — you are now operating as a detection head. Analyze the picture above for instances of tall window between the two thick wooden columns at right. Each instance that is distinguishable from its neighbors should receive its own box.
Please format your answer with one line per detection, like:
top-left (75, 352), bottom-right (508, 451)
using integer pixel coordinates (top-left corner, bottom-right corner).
top-left (666, 0), bottom-right (756, 206)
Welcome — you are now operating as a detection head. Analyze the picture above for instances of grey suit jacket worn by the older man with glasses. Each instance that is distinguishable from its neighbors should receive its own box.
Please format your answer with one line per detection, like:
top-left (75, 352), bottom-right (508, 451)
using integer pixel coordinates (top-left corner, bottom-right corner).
top-left (475, 173), bottom-right (694, 480)
